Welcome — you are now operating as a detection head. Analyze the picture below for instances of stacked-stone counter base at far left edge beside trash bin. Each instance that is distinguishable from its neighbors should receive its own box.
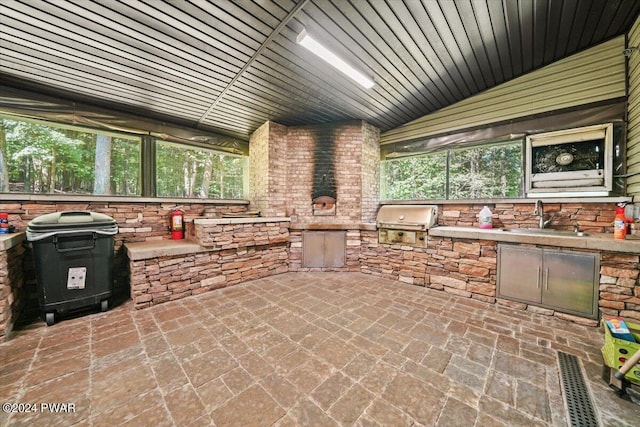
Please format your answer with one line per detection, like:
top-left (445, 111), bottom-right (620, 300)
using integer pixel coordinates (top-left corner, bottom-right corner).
top-left (0, 243), bottom-right (25, 342)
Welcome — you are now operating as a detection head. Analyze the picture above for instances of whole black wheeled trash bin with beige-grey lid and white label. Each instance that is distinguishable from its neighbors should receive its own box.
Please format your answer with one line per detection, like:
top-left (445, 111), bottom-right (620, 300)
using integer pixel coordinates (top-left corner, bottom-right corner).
top-left (27, 211), bottom-right (118, 326)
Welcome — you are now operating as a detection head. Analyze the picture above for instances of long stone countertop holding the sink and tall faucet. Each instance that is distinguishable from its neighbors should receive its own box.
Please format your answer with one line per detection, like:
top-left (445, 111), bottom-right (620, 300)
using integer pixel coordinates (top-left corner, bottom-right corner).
top-left (429, 226), bottom-right (640, 254)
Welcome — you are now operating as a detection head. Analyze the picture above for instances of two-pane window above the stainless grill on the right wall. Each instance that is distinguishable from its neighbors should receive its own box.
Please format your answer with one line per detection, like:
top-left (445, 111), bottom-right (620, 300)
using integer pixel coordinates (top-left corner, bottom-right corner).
top-left (381, 141), bottom-right (523, 200)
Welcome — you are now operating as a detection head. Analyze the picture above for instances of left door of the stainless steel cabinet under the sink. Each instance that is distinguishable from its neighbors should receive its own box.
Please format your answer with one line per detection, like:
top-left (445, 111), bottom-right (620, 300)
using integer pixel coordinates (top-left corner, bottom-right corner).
top-left (498, 245), bottom-right (542, 303)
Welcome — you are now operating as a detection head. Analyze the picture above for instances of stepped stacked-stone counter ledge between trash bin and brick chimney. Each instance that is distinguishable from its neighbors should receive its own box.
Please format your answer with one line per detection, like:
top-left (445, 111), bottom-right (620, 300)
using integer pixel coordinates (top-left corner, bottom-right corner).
top-left (125, 232), bottom-right (289, 309)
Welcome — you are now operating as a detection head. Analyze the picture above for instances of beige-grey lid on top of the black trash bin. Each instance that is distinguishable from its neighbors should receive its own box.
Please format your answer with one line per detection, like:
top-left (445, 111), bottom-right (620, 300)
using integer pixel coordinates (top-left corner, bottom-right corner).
top-left (27, 211), bottom-right (117, 234)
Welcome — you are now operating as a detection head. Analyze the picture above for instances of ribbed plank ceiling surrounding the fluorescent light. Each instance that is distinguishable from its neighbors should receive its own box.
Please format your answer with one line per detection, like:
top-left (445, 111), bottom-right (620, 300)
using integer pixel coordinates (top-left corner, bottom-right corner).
top-left (0, 0), bottom-right (640, 140)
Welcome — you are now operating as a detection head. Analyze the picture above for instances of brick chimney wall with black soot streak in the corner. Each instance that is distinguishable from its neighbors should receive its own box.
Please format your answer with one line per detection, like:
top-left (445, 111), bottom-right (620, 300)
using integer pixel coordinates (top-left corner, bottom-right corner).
top-left (250, 121), bottom-right (380, 224)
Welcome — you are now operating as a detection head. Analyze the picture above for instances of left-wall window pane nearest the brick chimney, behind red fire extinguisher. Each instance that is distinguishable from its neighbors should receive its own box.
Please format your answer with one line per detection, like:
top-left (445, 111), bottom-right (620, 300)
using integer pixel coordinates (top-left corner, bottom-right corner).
top-left (156, 141), bottom-right (247, 199)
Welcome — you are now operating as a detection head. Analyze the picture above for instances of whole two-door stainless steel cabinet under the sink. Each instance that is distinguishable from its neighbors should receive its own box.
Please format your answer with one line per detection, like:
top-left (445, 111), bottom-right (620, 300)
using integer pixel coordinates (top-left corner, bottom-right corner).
top-left (497, 244), bottom-right (600, 319)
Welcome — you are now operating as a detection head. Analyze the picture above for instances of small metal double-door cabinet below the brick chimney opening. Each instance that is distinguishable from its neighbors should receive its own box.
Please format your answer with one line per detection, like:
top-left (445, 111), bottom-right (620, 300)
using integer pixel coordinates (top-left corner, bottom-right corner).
top-left (302, 231), bottom-right (347, 268)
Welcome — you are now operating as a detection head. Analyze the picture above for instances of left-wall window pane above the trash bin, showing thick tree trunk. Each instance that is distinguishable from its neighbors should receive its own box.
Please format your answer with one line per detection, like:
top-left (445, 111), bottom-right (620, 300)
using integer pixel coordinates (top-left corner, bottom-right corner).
top-left (0, 117), bottom-right (140, 195)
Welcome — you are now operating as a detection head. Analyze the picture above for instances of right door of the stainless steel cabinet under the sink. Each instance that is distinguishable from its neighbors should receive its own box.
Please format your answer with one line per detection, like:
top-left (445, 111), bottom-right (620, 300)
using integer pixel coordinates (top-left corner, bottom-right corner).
top-left (542, 250), bottom-right (599, 315)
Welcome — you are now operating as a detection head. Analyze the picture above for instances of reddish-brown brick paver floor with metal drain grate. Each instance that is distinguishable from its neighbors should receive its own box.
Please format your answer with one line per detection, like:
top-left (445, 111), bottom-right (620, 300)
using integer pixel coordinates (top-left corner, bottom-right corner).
top-left (0, 273), bottom-right (640, 427)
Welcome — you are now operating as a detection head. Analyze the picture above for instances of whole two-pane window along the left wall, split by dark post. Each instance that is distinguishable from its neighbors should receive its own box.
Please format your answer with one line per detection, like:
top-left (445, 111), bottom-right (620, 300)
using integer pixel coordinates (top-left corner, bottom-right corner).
top-left (0, 116), bottom-right (248, 199)
